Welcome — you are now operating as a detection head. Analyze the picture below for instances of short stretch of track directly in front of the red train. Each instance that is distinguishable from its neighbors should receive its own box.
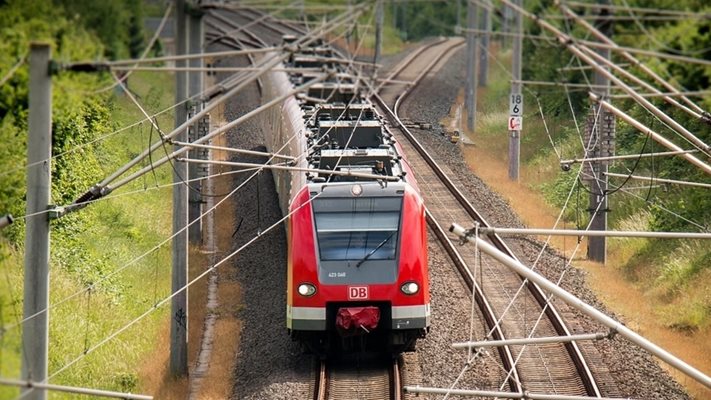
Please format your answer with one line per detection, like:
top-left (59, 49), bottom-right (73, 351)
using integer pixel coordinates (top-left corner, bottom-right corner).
top-left (313, 359), bottom-right (402, 400)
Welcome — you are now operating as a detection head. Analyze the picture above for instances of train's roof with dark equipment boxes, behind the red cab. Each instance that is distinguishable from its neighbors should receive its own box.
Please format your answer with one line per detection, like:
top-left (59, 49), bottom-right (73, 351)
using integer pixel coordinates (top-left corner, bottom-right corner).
top-left (290, 44), bottom-right (405, 185)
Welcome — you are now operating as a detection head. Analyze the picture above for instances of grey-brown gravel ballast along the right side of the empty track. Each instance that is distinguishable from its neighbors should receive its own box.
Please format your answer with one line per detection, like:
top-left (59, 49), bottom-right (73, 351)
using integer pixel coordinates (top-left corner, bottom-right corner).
top-left (400, 42), bottom-right (689, 399)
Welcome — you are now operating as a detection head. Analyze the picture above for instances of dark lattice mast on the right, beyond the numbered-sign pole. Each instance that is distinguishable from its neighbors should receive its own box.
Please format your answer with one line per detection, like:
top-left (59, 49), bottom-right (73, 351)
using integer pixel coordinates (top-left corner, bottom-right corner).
top-left (585, 0), bottom-right (615, 264)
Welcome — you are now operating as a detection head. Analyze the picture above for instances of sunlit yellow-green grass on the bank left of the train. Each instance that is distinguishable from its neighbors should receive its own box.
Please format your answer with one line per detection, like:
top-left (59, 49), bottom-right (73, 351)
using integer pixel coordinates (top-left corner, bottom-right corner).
top-left (0, 73), bottom-right (173, 399)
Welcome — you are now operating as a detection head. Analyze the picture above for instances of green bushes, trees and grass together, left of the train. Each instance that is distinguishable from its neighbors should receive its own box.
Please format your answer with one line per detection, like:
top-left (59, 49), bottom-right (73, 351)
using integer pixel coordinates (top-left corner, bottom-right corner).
top-left (0, 0), bottom-right (177, 398)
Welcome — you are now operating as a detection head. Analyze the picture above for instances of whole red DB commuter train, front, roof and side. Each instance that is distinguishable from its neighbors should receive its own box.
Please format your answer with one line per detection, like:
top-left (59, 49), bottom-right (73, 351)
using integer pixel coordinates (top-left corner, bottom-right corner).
top-left (265, 42), bottom-right (430, 355)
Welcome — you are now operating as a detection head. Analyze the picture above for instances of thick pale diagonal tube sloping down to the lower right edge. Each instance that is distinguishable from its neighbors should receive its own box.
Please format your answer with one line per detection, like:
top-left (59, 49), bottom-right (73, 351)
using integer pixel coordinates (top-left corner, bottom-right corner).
top-left (449, 224), bottom-right (711, 388)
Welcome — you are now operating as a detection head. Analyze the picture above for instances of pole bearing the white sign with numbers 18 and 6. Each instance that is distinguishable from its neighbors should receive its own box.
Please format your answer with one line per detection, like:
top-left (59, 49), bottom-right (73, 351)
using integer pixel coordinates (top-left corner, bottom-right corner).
top-left (508, 0), bottom-right (523, 181)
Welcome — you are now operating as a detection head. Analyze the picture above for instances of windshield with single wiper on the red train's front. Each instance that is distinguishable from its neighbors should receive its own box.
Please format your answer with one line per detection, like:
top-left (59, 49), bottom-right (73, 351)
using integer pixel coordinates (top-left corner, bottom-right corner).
top-left (313, 197), bottom-right (402, 266)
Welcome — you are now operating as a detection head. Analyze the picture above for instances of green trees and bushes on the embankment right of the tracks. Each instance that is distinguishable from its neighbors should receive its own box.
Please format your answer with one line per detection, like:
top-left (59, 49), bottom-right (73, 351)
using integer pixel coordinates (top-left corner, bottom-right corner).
top-left (522, 0), bottom-right (711, 329)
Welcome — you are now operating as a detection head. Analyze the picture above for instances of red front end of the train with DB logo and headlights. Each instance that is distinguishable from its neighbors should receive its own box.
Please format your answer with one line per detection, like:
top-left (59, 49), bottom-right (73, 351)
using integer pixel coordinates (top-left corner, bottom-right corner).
top-left (287, 181), bottom-right (430, 355)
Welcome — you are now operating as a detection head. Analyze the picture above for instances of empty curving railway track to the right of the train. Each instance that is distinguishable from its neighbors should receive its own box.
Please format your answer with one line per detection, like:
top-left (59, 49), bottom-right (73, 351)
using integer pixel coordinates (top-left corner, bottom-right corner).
top-left (373, 40), bottom-right (600, 397)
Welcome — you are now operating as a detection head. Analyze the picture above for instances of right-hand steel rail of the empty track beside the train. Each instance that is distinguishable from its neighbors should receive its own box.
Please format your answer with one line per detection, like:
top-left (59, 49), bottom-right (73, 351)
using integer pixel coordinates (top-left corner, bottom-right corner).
top-left (372, 39), bottom-right (600, 397)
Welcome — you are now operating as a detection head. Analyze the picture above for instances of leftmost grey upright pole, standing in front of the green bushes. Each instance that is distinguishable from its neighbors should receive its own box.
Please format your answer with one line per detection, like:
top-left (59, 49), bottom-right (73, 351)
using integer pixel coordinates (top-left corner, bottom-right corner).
top-left (22, 43), bottom-right (52, 400)
